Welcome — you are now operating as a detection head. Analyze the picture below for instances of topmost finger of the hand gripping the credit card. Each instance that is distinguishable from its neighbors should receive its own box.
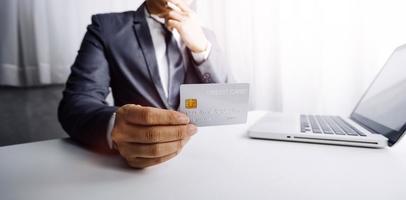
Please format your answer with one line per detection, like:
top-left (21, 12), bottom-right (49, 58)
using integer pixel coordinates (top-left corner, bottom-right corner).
top-left (123, 105), bottom-right (190, 125)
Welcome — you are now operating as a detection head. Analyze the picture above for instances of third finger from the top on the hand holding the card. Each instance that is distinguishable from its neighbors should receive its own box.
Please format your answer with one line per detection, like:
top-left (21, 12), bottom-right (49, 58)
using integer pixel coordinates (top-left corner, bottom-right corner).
top-left (118, 137), bottom-right (190, 159)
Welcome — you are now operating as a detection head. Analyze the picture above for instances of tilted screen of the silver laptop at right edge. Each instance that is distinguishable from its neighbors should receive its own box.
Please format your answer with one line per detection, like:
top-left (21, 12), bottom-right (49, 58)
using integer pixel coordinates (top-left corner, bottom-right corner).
top-left (351, 45), bottom-right (406, 146)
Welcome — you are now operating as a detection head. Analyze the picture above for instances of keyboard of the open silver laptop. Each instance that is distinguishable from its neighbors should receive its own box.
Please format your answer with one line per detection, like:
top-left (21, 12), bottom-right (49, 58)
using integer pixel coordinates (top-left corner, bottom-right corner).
top-left (300, 115), bottom-right (367, 136)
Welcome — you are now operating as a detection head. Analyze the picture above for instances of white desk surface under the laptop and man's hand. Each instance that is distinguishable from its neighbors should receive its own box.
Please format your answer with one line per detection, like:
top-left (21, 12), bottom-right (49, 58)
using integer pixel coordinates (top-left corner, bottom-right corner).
top-left (0, 112), bottom-right (406, 200)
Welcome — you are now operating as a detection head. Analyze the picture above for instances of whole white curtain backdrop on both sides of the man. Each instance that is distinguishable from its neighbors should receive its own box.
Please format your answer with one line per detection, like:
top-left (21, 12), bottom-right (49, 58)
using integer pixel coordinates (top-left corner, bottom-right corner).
top-left (0, 0), bottom-right (406, 114)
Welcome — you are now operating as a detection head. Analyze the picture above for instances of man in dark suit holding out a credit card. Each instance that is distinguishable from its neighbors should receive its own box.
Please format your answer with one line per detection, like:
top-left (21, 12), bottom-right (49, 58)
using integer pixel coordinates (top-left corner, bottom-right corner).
top-left (58, 0), bottom-right (230, 168)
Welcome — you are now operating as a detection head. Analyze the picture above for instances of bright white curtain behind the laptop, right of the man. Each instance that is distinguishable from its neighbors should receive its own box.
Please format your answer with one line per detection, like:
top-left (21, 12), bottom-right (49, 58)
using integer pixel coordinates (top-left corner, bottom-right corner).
top-left (197, 0), bottom-right (406, 115)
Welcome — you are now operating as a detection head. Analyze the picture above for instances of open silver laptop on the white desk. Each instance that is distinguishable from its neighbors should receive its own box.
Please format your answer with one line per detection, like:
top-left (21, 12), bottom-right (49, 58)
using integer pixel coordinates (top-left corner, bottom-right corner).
top-left (248, 45), bottom-right (406, 148)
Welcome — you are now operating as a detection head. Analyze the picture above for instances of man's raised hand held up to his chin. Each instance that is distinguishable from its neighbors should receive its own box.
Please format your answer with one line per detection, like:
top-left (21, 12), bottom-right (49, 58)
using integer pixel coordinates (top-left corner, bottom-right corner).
top-left (163, 0), bottom-right (208, 53)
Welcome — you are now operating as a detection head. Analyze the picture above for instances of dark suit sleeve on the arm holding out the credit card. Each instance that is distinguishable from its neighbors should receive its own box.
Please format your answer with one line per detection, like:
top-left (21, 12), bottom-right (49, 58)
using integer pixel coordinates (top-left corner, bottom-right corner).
top-left (58, 16), bottom-right (117, 151)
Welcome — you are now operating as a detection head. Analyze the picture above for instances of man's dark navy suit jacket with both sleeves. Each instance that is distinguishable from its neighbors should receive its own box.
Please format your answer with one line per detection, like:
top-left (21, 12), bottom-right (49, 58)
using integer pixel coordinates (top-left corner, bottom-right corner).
top-left (58, 4), bottom-right (229, 150)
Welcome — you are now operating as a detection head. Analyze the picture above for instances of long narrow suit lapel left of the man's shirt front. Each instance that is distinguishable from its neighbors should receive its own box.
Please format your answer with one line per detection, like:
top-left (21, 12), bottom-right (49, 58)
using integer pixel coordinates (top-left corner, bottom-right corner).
top-left (134, 3), bottom-right (170, 109)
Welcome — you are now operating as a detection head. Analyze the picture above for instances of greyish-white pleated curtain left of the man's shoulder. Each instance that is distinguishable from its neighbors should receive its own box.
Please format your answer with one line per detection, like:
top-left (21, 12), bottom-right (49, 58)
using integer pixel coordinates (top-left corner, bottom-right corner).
top-left (0, 0), bottom-right (143, 86)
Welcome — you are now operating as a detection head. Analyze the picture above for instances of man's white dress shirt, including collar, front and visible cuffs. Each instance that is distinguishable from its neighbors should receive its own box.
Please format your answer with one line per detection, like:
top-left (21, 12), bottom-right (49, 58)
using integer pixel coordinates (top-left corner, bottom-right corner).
top-left (107, 9), bottom-right (212, 149)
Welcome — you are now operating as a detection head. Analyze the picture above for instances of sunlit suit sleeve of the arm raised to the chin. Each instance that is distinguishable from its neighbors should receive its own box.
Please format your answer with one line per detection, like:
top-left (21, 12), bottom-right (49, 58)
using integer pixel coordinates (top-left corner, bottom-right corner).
top-left (194, 30), bottom-right (234, 83)
